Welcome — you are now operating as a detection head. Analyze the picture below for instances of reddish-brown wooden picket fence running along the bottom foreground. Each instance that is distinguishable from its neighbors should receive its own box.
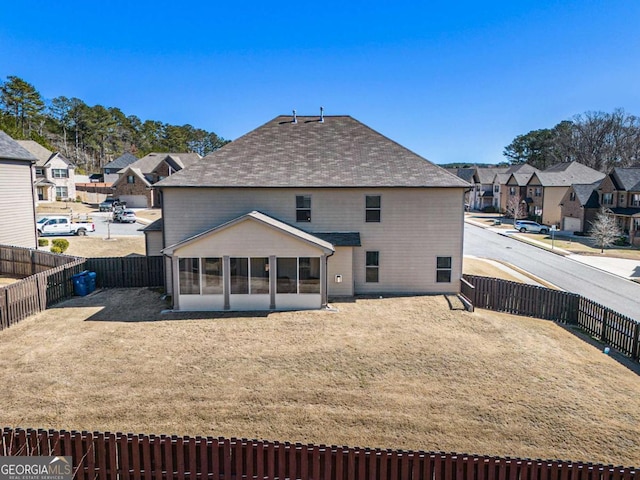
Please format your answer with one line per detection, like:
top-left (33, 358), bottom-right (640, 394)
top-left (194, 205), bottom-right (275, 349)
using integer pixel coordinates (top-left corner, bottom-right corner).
top-left (0, 428), bottom-right (640, 480)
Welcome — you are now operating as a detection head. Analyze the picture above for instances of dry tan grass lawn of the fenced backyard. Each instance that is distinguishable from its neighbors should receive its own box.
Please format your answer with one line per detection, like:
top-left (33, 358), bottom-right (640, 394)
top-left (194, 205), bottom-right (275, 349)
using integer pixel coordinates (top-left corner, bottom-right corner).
top-left (0, 289), bottom-right (640, 466)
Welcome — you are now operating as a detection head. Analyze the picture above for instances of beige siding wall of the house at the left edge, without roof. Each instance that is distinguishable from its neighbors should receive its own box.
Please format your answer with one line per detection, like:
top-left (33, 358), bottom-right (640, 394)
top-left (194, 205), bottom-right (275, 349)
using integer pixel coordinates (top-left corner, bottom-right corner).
top-left (0, 160), bottom-right (37, 248)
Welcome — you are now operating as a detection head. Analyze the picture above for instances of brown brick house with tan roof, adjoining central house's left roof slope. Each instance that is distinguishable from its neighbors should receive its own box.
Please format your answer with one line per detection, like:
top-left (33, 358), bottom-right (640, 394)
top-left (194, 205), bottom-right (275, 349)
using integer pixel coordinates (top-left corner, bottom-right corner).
top-left (112, 153), bottom-right (202, 208)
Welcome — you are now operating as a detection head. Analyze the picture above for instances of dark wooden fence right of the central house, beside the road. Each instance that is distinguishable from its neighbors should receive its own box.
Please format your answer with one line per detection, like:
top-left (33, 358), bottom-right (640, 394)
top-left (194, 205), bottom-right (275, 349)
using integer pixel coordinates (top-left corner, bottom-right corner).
top-left (461, 275), bottom-right (640, 360)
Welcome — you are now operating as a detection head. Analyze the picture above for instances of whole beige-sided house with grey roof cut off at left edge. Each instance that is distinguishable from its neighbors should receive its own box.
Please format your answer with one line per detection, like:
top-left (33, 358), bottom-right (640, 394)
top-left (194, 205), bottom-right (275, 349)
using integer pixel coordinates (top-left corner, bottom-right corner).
top-left (0, 130), bottom-right (38, 248)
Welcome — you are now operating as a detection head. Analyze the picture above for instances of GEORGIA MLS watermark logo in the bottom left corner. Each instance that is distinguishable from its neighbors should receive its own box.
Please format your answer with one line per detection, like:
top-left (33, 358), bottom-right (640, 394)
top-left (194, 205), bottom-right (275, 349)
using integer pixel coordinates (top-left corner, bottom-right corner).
top-left (0, 457), bottom-right (73, 480)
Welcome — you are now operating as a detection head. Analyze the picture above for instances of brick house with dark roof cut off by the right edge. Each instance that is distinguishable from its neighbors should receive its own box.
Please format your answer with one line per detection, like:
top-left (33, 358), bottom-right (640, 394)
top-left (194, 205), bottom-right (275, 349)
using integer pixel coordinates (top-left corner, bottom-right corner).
top-left (599, 167), bottom-right (640, 246)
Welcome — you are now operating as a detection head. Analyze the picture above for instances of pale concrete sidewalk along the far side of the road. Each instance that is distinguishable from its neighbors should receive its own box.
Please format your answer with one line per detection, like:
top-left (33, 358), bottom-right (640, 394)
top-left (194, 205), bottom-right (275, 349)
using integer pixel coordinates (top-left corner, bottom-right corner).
top-left (464, 218), bottom-right (640, 281)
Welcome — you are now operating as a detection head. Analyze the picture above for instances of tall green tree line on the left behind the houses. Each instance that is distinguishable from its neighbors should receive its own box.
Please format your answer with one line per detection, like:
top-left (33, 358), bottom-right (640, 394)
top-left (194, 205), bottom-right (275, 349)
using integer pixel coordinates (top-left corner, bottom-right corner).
top-left (0, 75), bottom-right (228, 173)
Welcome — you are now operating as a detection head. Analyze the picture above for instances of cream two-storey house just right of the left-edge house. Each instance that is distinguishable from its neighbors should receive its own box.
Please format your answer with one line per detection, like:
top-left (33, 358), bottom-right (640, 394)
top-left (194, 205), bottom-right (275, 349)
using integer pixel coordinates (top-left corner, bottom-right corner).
top-left (16, 140), bottom-right (76, 202)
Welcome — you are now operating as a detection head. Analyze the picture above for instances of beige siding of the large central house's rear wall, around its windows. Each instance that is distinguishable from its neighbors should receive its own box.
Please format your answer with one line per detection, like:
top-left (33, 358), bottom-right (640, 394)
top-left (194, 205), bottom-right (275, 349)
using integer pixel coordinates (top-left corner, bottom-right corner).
top-left (163, 188), bottom-right (464, 293)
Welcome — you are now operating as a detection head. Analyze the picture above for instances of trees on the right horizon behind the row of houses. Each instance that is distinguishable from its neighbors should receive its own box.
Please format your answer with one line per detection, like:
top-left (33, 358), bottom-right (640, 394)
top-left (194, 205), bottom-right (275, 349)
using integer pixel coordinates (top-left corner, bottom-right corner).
top-left (504, 109), bottom-right (640, 173)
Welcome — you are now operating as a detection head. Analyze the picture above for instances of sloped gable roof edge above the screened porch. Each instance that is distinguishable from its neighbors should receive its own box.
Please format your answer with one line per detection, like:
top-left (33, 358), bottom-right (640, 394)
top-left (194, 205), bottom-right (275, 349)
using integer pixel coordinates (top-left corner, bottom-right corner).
top-left (162, 210), bottom-right (336, 256)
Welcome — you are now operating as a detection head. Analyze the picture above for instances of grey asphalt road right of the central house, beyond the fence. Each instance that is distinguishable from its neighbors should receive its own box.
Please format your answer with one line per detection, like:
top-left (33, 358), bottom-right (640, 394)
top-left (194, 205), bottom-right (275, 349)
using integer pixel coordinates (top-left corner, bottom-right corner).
top-left (464, 223), bottom-right (640, 321)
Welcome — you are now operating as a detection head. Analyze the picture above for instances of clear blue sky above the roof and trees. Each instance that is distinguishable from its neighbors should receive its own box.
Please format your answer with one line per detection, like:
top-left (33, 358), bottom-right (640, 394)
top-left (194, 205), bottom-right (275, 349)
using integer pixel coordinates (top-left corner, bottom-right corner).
top-left (0, 0), bottom-right (640, 163)
